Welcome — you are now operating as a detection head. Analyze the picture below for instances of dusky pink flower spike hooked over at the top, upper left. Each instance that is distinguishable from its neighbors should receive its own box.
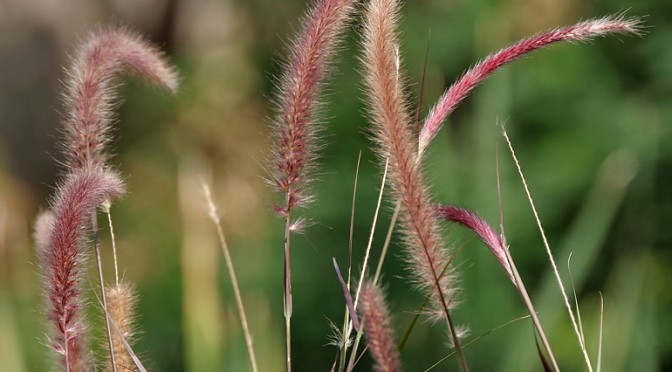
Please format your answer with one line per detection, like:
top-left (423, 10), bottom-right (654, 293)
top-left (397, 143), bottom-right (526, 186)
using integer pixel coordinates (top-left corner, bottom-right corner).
top-left (65, 28), bottom-right (178, 169)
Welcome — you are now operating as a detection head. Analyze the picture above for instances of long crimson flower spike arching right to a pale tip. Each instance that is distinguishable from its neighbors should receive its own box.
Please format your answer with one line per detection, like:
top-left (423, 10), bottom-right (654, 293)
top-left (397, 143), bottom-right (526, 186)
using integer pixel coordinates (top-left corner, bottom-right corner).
top-left (418, 15), bottom-right (640, 156)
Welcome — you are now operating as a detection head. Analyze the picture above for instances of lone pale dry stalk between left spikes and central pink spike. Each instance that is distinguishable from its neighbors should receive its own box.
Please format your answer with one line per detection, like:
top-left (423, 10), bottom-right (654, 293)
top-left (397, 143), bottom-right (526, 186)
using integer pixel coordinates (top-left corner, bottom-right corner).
top-left (203, 183), bottom-right (258, 372)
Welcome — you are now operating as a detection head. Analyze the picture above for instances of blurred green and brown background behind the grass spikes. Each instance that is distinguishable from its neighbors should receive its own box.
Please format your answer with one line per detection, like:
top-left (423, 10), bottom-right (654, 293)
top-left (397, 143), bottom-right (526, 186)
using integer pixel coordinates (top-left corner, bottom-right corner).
top-left (0, 0), bottom-right (672, 371)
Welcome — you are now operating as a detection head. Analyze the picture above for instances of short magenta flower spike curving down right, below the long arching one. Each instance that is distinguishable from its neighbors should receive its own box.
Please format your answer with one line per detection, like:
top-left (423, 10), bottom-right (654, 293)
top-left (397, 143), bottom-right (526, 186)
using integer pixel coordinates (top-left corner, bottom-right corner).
top-left (436, 205), bottom-right (516, 286)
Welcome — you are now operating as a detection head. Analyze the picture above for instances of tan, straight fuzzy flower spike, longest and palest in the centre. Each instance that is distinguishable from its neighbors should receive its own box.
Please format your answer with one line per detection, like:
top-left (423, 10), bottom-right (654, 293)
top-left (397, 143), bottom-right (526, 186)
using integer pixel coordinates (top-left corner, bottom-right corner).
top-left (362, 0), bottom-right (468, 371)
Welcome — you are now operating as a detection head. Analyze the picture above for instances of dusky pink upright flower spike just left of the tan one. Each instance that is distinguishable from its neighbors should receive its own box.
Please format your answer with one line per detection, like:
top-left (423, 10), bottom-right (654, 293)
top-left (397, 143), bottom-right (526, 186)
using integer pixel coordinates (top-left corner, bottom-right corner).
top-left (270, 0), bottom-right (353, 214)
